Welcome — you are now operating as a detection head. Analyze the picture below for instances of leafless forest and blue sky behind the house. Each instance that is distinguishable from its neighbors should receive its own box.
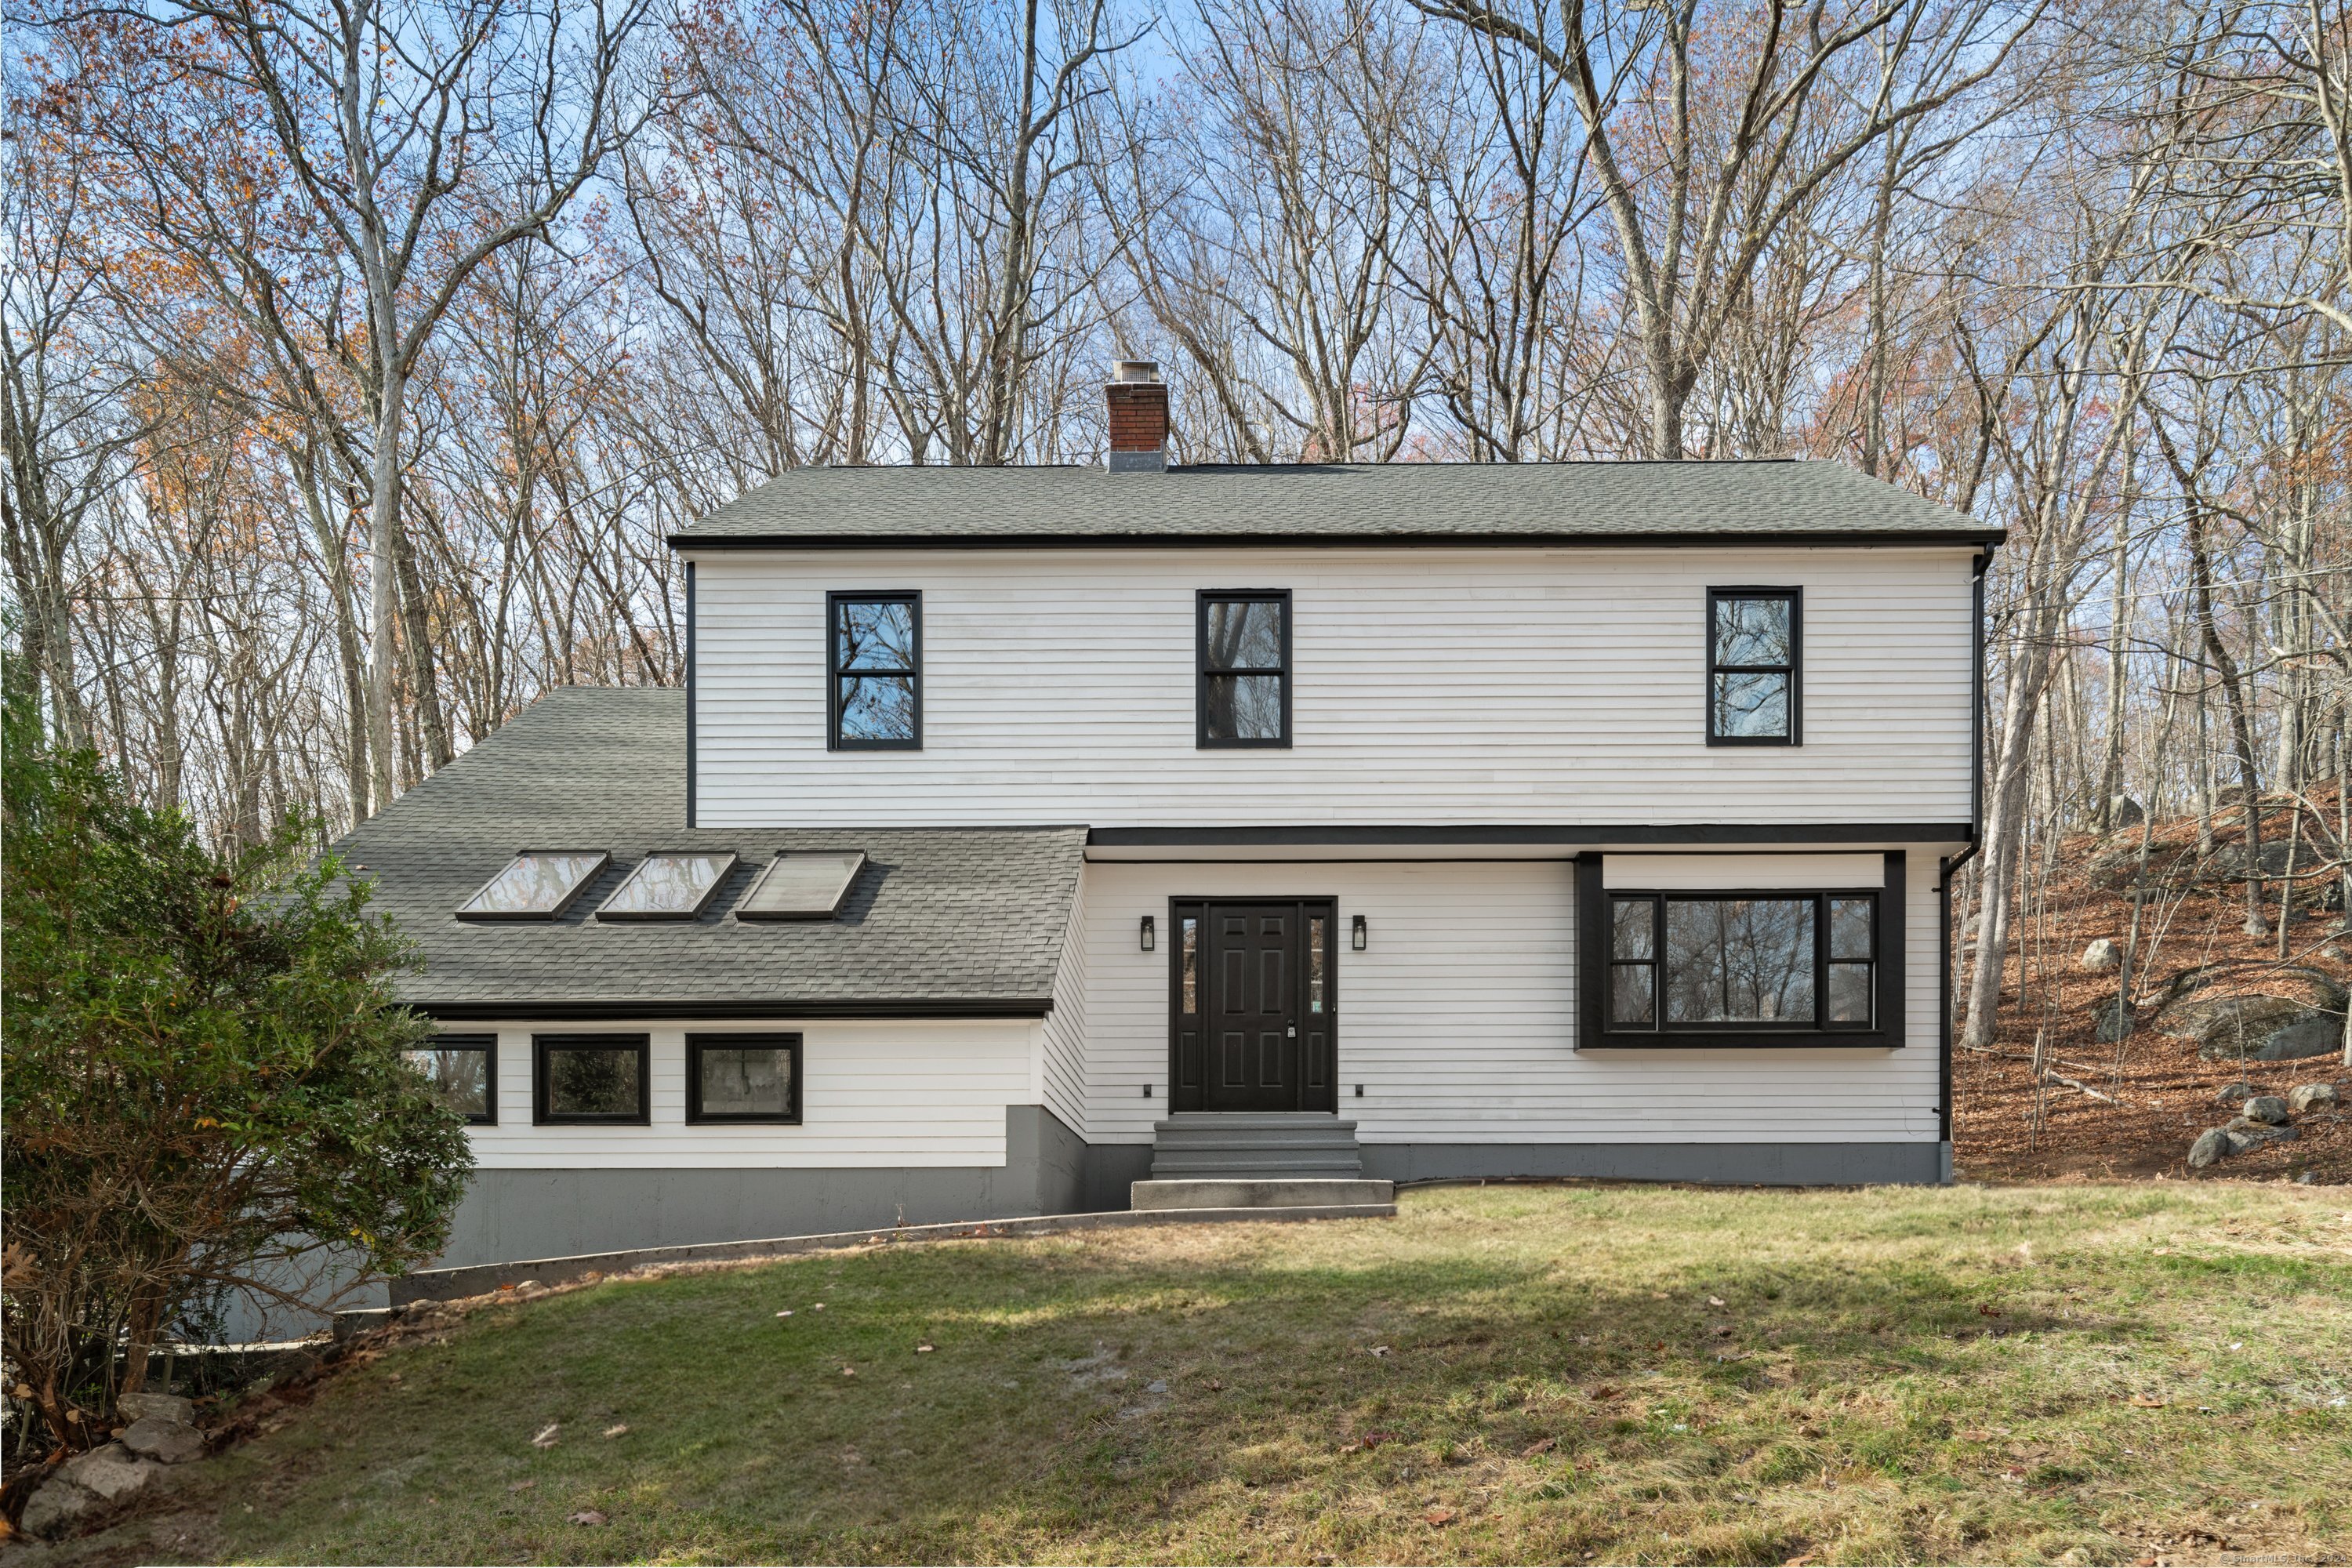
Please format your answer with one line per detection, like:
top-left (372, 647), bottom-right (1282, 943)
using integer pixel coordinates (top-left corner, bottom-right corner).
top-left (0, 0), bottom-right (2352, 1062)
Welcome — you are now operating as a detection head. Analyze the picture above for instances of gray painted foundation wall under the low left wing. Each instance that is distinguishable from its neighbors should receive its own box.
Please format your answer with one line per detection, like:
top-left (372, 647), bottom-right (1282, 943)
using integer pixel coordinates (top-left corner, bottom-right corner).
top-left (433, 1105), bottom-right (1082, 1269)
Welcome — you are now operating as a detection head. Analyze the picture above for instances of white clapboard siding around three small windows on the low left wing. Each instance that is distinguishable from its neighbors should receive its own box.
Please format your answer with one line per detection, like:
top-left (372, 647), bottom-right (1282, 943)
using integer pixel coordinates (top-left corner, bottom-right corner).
top-left (440, 1020), bottom-right (1040, 1171)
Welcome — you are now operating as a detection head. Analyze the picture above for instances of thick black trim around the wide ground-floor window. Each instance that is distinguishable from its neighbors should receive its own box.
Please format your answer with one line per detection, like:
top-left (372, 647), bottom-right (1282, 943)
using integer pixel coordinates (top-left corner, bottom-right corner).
top-left (1576, 851), bottom-right (1905, 1051)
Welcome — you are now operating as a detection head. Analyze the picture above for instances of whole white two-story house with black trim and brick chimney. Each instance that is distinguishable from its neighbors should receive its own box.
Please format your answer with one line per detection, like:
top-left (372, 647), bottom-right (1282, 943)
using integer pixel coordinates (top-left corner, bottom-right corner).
top-left (346, 365), bottom-right (2002, 1265)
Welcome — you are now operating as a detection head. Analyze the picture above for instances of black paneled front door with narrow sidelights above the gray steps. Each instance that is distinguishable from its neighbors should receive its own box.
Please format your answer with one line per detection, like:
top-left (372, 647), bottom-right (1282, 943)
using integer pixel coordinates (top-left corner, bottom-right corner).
top-left (1169, 898), bottom-right (1338, 1109)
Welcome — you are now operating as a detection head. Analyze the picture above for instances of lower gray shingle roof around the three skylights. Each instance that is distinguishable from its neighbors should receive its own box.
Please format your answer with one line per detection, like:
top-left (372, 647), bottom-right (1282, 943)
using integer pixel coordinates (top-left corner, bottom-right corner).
top-left (341, 687), bottom-right (1087, 1018)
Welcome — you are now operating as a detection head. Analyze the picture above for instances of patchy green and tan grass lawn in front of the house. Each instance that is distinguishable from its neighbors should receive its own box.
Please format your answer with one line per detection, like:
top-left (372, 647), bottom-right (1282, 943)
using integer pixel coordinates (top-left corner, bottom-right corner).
top-left (78, 1182), bottom-right (2352, 1563)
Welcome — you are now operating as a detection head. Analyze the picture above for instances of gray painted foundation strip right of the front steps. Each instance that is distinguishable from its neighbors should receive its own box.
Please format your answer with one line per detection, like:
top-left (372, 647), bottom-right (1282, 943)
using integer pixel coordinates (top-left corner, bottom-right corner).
top-left (1364, 1142), bottom-right (1952, 1187)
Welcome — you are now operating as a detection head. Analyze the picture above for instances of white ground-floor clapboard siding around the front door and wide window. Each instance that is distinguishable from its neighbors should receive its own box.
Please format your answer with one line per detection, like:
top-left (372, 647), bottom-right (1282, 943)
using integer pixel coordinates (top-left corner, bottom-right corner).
top-left (1087, 853), bottom-right (1938, 1142)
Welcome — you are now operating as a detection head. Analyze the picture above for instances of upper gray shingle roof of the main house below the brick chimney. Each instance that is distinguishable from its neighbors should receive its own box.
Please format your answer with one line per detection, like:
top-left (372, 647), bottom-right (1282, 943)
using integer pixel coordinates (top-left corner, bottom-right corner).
top-left (670, 461), bottom-right (2002, 550)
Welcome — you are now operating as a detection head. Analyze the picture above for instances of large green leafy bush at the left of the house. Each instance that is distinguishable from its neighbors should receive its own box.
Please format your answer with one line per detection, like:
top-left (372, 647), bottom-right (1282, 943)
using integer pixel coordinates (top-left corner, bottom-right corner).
top-left (0, 694), bottom-right (470, 1448)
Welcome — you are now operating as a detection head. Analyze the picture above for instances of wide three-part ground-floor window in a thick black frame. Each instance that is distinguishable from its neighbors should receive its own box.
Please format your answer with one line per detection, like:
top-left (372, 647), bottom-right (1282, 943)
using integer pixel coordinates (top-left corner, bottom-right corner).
top-left (1578, 855), bottom-right (1903, 1046)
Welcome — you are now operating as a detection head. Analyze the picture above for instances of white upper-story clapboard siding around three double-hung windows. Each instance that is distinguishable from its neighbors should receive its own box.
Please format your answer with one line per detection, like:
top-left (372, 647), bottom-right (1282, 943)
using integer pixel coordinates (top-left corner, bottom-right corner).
top-left (696, 548), bottom-right (1971, 827)
